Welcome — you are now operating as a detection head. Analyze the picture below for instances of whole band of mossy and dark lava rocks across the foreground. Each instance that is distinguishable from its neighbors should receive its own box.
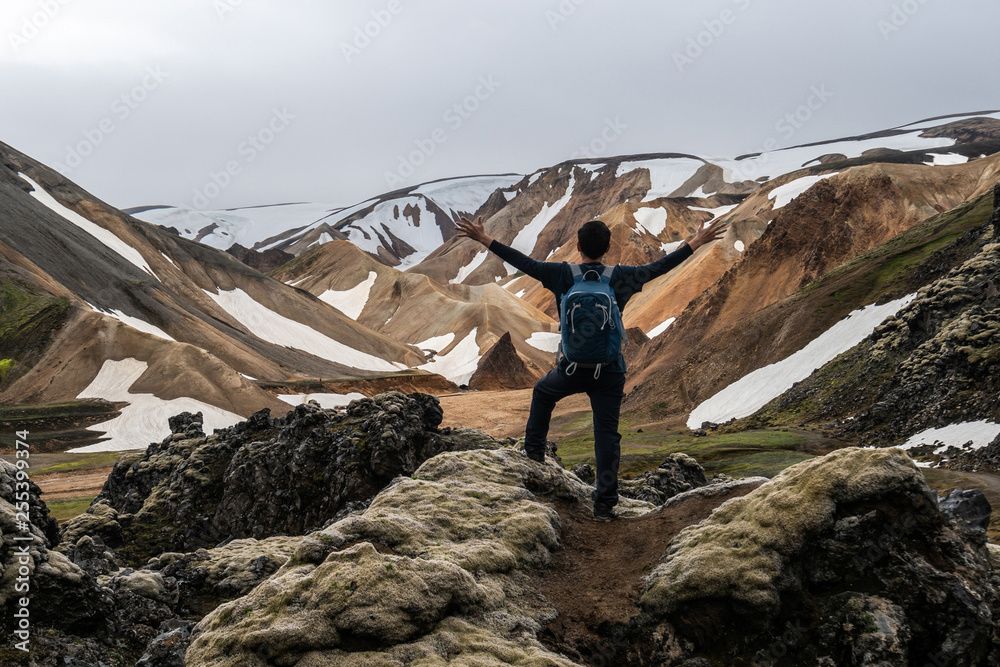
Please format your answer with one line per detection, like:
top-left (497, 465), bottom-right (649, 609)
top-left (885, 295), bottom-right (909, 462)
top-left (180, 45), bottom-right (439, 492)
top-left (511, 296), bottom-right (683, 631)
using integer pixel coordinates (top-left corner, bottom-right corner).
top-left (0, 393), bottom-right (1000, 667)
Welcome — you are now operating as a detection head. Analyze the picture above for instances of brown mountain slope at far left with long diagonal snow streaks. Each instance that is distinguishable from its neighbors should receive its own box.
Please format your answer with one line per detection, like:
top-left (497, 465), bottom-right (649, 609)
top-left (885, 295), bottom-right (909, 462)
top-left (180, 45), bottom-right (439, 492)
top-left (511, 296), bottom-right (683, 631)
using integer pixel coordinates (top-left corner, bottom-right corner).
top-left (0, 144), bottom-right (423, 422)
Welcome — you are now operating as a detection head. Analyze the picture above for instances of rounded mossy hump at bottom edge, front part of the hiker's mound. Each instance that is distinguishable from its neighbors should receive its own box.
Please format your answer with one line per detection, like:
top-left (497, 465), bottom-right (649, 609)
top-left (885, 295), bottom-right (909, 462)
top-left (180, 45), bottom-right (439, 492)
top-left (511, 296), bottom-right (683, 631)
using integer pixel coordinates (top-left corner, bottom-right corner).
top-left (188, 542), bottom-right (494, 666)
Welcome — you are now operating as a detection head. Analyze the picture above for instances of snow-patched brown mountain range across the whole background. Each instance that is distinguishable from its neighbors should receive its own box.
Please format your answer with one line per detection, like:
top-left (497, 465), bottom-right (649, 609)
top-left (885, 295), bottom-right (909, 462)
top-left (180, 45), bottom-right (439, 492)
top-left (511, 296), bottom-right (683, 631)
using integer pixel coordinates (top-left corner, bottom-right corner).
top-left (7, 112), bottom-right (1000, 447)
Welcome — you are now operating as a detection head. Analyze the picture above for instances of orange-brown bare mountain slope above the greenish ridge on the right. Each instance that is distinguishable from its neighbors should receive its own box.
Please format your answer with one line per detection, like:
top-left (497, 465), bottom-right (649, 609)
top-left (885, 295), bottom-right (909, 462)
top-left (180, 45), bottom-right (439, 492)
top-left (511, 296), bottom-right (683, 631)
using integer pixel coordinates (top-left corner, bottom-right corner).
top-left (648, 154), bottom-right (1000, 352)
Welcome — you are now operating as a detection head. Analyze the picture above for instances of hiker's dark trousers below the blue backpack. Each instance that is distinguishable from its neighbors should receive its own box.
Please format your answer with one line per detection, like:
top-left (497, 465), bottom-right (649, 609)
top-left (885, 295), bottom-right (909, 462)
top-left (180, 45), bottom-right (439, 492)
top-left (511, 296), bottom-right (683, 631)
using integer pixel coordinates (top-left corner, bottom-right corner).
top-left (524, 367), bottom-right (625, 505)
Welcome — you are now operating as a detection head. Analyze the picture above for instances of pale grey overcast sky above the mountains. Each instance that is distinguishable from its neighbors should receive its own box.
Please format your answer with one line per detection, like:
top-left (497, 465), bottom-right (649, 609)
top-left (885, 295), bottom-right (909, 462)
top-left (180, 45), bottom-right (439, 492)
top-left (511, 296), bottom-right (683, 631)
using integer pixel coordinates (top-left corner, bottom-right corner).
top-left (0, 0), bottom-right (1000, 208)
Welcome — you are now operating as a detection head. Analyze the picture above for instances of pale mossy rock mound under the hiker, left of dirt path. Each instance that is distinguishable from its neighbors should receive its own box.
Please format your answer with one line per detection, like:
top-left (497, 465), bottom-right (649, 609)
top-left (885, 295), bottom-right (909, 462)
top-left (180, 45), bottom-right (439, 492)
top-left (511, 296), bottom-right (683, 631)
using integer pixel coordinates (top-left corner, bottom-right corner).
top-left (186, 447), bottom-right (624, 667)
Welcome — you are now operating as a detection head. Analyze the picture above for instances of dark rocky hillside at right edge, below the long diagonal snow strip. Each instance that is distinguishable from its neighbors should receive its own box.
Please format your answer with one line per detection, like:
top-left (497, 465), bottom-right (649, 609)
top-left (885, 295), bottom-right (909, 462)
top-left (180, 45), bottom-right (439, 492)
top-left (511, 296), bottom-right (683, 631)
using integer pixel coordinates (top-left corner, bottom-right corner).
top-left (748, 202), bottom-right (1000, 448)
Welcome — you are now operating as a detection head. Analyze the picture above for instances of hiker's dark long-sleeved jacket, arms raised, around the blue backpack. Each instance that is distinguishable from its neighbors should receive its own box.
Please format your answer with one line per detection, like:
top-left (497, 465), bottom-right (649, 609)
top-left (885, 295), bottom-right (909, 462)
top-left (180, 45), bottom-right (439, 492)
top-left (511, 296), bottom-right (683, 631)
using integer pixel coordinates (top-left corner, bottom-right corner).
top-left (489, 239), bottom-right (693, 373)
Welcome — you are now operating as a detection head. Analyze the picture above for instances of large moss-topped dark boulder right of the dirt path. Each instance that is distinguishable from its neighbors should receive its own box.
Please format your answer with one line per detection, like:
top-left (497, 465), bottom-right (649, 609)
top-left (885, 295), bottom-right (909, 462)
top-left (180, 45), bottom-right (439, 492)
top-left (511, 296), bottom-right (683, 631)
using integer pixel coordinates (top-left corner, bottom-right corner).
top-left (640, 448), bottom-right (998, 665)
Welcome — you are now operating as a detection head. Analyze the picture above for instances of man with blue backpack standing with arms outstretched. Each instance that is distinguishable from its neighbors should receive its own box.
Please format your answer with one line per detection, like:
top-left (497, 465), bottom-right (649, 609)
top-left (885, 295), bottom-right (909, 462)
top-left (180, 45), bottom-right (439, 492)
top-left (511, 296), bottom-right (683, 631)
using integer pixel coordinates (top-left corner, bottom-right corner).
top-left (455, 216), bottom-right (728, 521)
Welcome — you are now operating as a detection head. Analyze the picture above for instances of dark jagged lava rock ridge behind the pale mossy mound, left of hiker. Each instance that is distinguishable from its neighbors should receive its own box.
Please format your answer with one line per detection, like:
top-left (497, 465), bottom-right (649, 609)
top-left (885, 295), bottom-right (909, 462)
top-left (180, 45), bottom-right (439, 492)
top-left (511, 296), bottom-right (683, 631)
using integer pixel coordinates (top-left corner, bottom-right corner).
top-left (69, 392), bottom-right (497, 563)
